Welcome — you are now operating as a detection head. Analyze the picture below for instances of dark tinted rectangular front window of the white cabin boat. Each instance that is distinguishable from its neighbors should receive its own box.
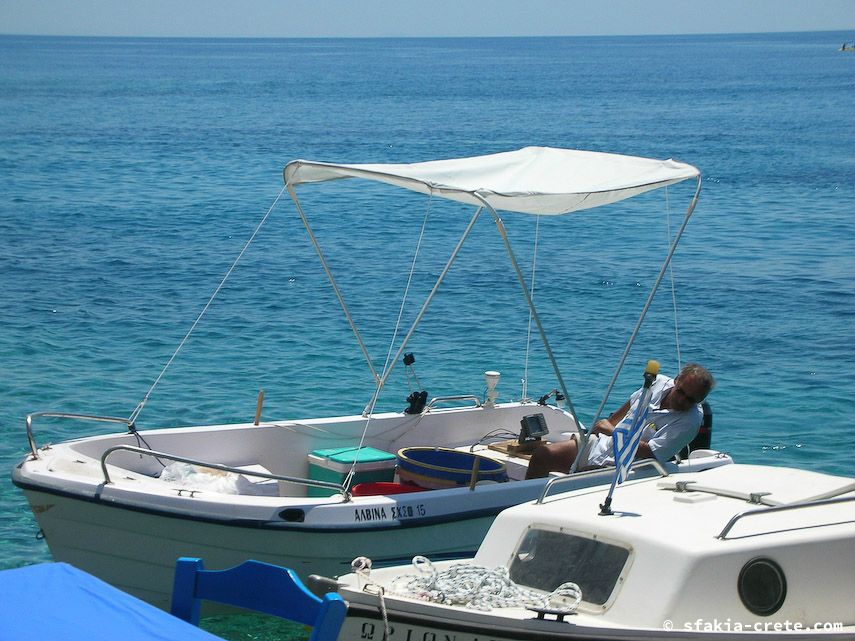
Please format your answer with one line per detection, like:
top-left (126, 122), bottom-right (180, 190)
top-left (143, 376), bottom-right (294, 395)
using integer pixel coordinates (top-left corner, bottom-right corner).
top-left (510, 528), bottom-right (629, 606)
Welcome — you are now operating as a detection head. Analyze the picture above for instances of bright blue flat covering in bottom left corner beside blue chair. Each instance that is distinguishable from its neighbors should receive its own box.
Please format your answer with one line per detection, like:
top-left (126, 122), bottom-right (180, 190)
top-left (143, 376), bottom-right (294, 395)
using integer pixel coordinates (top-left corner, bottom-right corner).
top-left (0, 563), bottom-right (222, 641)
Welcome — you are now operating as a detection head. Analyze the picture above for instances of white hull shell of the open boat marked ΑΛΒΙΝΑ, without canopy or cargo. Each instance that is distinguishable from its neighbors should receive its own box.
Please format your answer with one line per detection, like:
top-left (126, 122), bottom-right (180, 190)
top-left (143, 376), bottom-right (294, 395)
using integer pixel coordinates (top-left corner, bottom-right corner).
top-left (12, 404), bottom-right (730, 608)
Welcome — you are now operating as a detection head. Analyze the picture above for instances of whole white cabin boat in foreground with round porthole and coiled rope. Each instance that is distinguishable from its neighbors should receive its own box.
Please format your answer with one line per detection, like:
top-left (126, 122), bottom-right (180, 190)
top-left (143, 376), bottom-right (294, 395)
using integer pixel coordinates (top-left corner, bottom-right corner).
top-left (338, 464), bottom-right (855, 641)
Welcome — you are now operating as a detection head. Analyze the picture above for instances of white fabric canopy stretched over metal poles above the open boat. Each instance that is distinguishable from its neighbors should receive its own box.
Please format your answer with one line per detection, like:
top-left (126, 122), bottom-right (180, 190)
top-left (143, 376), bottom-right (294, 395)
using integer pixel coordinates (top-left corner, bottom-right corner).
top-left (283, 147), bottom-right (700, 215)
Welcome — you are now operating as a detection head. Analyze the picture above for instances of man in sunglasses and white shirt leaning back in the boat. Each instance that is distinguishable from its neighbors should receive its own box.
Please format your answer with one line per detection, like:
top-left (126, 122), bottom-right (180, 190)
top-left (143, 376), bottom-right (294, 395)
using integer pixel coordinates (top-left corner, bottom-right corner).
top-left (526, 363), bottom-right (715, 479)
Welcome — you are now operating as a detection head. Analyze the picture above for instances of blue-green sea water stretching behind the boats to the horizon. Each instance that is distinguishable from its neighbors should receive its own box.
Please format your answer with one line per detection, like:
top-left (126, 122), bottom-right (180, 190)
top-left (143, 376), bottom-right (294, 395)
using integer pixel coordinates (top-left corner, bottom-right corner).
top-left (0, 33), bottom-right (855, 580)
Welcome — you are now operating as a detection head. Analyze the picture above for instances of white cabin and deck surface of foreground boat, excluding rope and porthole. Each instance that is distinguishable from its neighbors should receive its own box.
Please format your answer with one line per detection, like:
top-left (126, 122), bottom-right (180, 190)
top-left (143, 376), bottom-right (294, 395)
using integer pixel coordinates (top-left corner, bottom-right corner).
top-left (341, 465), bottom-right (855, 638)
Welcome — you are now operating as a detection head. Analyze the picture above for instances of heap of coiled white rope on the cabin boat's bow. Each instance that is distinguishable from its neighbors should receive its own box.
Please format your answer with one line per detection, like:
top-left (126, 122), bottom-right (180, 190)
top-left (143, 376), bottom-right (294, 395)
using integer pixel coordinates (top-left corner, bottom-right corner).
top-left (352, 556), bottom-right (582, 621)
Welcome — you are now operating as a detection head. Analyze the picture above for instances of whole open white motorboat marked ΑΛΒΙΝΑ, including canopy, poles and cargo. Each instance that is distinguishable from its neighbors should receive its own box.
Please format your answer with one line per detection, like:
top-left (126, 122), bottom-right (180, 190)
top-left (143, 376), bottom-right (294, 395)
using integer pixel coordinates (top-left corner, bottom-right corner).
top-left (12, 148), bottom-right (731, 607)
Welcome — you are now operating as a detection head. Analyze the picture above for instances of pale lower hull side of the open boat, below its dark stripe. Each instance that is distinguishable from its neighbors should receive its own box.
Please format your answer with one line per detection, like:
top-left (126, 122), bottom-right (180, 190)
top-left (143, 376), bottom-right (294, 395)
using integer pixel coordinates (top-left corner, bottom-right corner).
top-left (20, 490), bottom-right (494, 609)
